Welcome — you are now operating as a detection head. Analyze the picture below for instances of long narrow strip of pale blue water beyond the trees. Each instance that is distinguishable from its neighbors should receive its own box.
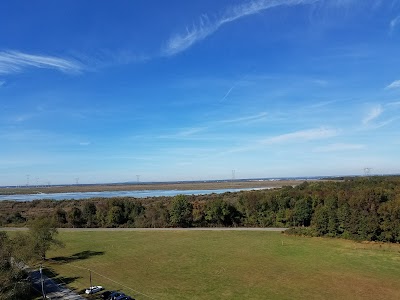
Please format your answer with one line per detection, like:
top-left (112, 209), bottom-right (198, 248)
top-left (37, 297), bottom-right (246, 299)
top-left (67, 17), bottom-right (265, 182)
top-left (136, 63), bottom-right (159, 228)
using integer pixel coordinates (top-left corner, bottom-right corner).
top-left (0, 188), bottom-right (266, 201)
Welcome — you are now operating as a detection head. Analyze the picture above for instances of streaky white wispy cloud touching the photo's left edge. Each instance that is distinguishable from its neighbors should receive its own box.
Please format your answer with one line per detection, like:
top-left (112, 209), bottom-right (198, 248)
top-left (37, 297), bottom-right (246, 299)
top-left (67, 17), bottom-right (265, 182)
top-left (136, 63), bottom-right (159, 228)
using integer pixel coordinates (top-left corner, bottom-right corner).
top-left (0, 51), bottom-right (83, 74)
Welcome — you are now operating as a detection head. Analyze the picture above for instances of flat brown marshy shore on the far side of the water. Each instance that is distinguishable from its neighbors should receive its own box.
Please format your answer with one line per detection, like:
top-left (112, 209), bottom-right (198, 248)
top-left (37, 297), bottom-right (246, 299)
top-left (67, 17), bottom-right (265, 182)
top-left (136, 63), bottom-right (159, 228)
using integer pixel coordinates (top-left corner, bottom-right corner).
top-left (0, 179), bottom-right (318, 195)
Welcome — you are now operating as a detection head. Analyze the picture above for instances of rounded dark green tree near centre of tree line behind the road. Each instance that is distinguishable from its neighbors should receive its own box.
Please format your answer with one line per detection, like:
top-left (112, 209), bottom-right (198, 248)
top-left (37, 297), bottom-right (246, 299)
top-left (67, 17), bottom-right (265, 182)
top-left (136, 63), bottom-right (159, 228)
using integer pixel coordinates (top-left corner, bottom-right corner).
top-left (169, 195), bottom-right (193, 227)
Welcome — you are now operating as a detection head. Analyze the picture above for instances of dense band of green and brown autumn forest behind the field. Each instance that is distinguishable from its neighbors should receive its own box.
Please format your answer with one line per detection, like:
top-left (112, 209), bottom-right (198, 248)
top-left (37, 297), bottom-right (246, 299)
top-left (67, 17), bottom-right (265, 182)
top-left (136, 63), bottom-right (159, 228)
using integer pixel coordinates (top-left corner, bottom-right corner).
top-left (0, 176), bottom-right (400, 242)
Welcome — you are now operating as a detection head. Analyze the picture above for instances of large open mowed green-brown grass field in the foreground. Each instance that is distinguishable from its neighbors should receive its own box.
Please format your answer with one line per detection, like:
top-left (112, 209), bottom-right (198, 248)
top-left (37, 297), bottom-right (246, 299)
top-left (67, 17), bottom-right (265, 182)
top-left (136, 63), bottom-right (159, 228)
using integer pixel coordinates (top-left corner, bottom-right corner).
top-left (46, 231), bottom-right (400, 300)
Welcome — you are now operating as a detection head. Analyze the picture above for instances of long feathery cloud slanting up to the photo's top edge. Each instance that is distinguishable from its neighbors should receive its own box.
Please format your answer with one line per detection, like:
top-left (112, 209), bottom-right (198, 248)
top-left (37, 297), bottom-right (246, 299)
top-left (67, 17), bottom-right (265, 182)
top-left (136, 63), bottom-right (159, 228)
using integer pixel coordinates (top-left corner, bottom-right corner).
top-left (163, 0), bottom-right (319, 56)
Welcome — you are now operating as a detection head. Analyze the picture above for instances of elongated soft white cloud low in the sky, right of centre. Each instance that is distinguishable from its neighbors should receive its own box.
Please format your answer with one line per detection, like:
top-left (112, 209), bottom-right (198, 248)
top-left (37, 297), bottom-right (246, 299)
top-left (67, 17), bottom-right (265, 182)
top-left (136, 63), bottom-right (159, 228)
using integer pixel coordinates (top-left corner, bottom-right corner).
top-left (262, 127), bottom-right (338, 144)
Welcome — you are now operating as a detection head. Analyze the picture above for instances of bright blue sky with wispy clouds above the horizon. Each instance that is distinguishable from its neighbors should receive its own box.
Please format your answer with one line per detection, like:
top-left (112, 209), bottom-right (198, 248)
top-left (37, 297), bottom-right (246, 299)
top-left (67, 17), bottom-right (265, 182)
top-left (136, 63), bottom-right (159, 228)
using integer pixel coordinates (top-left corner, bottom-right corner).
top-left (0, 0), bottom-right (400, 185)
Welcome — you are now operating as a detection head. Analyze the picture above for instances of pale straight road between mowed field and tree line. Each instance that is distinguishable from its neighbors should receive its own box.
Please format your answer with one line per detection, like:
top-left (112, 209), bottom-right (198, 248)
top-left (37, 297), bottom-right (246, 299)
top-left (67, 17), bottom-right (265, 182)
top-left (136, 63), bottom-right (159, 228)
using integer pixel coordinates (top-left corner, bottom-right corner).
top-left (0, 227), bottom-right (287, 231)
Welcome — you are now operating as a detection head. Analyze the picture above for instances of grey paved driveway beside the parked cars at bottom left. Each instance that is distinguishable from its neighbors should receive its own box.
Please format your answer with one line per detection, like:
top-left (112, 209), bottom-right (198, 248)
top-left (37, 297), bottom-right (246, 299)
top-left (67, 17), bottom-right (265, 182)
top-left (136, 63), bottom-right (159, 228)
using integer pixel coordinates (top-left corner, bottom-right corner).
top-left (31, 270), bottom-right (85, 300)
